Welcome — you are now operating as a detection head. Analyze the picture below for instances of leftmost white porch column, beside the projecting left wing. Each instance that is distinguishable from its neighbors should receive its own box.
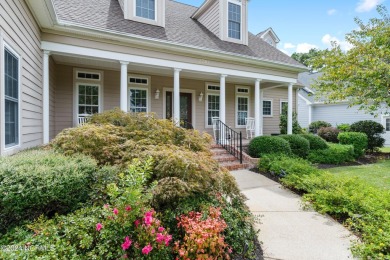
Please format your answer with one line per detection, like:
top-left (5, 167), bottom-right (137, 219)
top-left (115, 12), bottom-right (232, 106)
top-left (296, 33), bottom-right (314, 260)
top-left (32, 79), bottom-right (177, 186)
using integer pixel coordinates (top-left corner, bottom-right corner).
top-left (42, 51), bottom-right (50, 144)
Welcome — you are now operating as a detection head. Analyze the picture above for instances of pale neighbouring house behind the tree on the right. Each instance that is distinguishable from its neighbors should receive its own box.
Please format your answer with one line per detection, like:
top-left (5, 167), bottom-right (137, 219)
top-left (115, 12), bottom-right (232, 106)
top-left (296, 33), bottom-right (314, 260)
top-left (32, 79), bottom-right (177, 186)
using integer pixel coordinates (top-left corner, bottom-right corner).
top-left (298, 72), bottom-right (390, 146)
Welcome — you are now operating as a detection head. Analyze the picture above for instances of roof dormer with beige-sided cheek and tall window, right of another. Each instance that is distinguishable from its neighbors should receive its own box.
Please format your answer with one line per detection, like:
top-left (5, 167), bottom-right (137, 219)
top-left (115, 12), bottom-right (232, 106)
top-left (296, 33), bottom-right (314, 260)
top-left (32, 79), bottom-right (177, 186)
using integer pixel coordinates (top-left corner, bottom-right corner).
top-left (192, 0), bottom-right (248, 45)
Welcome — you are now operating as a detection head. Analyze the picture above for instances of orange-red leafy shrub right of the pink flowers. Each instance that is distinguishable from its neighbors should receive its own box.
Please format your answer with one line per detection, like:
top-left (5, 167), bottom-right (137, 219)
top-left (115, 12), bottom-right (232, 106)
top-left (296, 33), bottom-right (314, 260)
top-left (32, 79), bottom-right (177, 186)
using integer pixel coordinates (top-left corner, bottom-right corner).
top-left (175, 207), bottom-right (232, 259)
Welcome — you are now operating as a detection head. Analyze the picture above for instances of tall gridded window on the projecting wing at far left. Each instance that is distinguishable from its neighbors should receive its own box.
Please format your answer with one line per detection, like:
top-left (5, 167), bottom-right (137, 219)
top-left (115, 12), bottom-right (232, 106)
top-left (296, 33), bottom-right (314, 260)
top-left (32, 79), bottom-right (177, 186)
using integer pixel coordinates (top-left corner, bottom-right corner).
top-left (4, 48), bottom-right (19, 148)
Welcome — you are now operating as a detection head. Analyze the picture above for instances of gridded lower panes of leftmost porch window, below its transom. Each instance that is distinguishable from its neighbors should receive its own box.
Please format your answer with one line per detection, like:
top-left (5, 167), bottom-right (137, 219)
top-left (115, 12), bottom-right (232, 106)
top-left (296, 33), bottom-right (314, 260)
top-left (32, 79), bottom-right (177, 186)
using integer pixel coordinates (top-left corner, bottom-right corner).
top-left (78, 85), bottom-right (99, 115)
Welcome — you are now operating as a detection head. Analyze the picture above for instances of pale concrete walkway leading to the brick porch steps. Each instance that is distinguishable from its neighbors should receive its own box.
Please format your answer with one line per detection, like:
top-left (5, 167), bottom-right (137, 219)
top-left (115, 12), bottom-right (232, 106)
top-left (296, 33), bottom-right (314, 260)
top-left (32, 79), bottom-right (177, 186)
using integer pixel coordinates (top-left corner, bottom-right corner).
top-left (231, 170), bottom-right (356, 260)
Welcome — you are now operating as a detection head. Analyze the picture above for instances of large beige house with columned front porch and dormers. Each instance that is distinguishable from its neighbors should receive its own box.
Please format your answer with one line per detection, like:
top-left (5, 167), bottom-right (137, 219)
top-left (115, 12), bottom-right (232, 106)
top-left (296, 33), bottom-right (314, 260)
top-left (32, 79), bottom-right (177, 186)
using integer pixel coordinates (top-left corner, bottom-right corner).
top-left (0, 0), bottom-right (306, 155)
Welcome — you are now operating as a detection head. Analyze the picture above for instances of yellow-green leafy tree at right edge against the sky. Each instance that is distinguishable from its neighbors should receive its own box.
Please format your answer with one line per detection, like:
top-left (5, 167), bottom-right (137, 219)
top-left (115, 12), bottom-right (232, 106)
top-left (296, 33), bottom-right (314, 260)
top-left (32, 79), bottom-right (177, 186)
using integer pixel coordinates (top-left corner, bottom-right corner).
top-left (310, 5), bottom-right (390, 114)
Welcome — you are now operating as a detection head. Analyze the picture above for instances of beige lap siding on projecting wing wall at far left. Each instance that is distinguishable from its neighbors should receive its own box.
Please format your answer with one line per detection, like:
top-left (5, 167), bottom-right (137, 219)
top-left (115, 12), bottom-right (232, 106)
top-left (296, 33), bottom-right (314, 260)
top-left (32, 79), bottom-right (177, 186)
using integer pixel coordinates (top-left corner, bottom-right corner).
top-left (0, 0), bottom-right (43, 153)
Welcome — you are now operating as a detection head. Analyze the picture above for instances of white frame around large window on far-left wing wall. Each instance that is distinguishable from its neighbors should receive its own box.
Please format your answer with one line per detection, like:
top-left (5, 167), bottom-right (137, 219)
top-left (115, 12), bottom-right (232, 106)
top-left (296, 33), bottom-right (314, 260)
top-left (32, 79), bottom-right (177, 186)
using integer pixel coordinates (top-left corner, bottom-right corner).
top-left (0, 39), bottom-right (23, 155)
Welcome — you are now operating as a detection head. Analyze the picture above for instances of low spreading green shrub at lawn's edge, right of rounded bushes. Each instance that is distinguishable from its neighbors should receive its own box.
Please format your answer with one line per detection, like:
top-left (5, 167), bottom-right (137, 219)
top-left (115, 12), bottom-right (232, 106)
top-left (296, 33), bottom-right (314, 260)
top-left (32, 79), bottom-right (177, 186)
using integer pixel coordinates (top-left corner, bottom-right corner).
top-left (307, 144), bottom-right (354, 164)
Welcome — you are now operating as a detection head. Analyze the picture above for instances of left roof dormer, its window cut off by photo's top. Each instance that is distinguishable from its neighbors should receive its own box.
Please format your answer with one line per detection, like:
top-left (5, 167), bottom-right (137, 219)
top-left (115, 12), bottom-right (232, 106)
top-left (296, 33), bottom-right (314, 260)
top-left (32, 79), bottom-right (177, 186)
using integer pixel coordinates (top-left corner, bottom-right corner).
top-left (118, 0), bottom-right (165, 27)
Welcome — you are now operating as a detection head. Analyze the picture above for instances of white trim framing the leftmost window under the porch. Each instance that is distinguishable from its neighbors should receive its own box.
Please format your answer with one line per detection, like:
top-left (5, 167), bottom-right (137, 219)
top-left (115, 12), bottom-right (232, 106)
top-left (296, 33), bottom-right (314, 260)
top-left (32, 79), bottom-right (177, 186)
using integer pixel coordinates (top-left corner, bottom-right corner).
top-left (73, 68), bottom-right (104, 126)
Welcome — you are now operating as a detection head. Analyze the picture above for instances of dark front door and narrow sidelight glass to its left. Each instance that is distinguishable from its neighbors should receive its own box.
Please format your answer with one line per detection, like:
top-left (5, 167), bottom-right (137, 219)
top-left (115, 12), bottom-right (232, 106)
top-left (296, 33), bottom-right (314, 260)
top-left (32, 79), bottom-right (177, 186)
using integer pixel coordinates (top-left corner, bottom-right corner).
top-left (165, 92), bottom-right (192, 128)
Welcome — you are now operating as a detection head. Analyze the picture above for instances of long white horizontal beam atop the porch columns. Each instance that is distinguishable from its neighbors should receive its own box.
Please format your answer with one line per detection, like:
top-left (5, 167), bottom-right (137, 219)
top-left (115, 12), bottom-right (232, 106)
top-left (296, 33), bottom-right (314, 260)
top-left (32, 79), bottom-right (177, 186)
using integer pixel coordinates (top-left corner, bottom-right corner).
top-left (41, 41), bottom-right (297, 83)
